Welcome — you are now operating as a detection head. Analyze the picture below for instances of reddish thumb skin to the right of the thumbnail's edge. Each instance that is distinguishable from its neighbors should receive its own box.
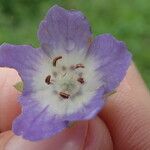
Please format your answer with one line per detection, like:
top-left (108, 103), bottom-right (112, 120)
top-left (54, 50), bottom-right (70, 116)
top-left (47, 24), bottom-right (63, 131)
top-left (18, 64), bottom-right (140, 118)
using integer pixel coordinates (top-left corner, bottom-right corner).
top-left (82, 117), bottom-right (113, 150)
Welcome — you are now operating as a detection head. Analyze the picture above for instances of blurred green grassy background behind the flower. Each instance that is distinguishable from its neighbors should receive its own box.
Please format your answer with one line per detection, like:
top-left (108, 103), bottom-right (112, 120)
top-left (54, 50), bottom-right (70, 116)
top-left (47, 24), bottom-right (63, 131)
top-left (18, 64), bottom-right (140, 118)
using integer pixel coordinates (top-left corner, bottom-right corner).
top-left (0, 0), bottom-right (150, 88)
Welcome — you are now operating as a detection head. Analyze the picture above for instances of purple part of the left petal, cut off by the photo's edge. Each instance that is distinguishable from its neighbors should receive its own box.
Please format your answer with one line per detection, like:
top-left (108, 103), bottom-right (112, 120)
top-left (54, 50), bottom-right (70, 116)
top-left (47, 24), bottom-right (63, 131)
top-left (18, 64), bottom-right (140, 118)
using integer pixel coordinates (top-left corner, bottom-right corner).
top-left (0, 44), bottom-right (46, 91)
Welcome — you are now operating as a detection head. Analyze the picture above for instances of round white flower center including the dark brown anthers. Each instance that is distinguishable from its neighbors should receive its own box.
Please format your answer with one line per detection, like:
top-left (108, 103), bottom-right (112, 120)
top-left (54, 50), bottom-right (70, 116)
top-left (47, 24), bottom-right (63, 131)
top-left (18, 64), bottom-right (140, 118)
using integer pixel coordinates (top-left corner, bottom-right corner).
top-left (33, 51), bottom-right (103, 115)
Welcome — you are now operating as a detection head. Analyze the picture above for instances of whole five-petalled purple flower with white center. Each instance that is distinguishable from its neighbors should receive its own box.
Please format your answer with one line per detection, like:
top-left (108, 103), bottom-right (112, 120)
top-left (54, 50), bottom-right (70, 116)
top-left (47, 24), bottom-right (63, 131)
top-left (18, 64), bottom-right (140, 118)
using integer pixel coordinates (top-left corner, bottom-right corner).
top-left (0, 5), bottom-right (131, 141)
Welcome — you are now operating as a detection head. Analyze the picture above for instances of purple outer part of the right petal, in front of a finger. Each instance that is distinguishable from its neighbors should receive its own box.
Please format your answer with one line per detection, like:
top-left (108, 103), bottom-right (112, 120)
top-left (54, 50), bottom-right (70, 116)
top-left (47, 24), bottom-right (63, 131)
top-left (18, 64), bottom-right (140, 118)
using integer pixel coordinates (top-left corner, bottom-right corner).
top-left (88, 34), bottom-right (131, 93)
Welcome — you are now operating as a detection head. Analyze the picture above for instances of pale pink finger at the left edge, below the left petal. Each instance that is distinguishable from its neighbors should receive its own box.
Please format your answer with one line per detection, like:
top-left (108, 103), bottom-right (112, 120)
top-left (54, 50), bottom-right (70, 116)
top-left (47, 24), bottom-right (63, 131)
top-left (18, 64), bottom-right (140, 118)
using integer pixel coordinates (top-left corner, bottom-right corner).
top-left (0, 68), bottom-right (20, 132)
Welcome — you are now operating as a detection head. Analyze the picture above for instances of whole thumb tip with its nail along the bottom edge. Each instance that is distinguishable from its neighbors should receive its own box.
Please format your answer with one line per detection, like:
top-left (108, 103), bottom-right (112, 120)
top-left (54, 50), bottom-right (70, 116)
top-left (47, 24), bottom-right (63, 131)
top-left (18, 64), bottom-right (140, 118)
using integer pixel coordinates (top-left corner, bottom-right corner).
top-left (0, 118), bottom-right (112, 150)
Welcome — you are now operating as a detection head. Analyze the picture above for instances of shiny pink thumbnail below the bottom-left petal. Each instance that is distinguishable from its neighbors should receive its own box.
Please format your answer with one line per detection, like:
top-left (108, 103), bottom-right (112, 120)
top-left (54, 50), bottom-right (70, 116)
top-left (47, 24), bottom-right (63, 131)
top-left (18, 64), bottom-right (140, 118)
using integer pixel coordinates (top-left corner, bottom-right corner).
top-left (5, 121), bottom-right (88, 150)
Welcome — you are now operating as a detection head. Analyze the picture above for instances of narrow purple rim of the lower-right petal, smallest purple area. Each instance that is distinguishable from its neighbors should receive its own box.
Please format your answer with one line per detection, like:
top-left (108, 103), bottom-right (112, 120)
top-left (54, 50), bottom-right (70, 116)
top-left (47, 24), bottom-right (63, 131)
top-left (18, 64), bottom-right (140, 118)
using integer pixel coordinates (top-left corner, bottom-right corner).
top-left (64, 88), bottom-right (105, 121)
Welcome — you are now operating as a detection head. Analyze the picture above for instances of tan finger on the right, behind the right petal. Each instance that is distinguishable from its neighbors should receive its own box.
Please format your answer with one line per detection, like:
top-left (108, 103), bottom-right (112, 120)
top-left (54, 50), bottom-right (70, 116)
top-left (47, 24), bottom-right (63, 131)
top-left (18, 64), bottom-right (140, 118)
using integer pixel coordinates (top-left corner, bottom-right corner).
top-left (101, 64), bottom-right (150, 150)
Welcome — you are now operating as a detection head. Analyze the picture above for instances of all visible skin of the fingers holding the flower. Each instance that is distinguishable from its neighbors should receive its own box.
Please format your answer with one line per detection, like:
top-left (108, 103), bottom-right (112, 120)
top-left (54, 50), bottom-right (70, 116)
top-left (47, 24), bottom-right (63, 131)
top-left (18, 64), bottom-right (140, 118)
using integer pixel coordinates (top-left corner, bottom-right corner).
top-left (0, 64), bottom-right (150, 150)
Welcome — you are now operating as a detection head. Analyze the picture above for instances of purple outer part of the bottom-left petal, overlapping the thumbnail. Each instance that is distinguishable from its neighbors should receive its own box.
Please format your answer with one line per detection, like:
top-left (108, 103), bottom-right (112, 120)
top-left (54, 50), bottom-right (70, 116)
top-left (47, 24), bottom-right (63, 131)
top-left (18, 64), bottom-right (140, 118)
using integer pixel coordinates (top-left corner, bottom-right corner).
top-left (13, 96), bottom-right (67, 141)
